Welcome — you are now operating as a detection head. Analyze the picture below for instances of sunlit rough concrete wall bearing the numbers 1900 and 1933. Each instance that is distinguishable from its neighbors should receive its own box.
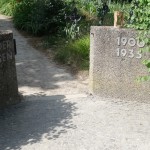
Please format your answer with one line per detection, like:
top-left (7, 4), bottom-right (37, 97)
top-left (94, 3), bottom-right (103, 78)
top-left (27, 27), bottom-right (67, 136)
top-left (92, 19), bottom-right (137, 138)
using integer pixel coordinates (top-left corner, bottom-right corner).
top-left (90, 26), bottom-right (150, 100)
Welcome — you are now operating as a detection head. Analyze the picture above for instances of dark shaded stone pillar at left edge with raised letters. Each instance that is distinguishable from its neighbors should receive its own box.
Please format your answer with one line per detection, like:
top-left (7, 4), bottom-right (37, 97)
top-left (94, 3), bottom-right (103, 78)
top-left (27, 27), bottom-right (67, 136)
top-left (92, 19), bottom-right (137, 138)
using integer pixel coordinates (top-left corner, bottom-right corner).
top-left (0, 30), bottom-right (19, 107)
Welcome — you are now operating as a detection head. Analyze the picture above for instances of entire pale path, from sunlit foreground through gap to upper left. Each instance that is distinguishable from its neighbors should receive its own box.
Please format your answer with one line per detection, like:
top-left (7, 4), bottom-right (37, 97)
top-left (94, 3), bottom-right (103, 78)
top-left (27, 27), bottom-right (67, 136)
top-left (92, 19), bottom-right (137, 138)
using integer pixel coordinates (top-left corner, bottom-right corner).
top-left (0, 15), bottom-right (150, 150)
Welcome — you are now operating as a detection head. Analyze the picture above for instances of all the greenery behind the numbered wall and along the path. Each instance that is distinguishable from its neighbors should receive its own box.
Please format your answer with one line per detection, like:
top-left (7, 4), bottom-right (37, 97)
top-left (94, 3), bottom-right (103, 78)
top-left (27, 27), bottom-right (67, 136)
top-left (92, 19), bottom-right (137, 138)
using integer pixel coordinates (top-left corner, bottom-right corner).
top-left (0, 0), bottom-right (150, 79)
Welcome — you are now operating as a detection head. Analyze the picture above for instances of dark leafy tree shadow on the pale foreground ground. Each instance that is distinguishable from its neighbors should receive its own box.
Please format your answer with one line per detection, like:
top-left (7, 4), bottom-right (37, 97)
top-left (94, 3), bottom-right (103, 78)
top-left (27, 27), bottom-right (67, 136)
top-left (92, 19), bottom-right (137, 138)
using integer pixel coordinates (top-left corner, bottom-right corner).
top-left (0, 95), bottom-right (77, 150)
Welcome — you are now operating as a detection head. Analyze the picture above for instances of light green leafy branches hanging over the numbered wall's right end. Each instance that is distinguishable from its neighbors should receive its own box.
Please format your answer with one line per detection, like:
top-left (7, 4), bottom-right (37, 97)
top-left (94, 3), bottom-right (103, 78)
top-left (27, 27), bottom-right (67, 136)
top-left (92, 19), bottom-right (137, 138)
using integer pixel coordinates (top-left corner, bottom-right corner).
top-left (130, 0), bottom-right (150, 81)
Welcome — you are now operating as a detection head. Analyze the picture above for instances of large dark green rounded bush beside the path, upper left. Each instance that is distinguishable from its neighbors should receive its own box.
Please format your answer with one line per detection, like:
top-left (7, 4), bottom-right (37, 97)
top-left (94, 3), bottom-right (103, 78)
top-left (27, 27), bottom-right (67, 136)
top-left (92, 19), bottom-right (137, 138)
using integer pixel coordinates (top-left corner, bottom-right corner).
top-left (13, 0), bottom-right (65, 35)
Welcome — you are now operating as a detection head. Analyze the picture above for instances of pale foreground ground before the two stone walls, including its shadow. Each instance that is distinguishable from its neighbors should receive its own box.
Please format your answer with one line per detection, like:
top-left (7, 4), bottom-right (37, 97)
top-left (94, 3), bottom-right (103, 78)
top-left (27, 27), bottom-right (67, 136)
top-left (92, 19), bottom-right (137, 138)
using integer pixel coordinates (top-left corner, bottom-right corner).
top-left (0, 95), bottom-right (150, 150)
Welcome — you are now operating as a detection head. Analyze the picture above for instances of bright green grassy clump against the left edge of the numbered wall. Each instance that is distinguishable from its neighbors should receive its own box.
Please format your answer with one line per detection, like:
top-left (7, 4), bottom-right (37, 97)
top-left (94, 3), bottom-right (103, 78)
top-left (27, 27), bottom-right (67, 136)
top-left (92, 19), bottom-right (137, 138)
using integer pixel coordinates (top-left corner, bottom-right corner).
top-left (55, 35), bottom-right (90, 69)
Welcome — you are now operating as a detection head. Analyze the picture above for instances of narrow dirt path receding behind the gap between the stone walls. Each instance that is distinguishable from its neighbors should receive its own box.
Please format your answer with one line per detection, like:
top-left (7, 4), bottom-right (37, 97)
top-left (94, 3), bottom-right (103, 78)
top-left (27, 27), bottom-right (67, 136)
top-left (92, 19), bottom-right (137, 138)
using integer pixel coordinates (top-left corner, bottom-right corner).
top-left (0, 15), bottom-right (88, 95)
